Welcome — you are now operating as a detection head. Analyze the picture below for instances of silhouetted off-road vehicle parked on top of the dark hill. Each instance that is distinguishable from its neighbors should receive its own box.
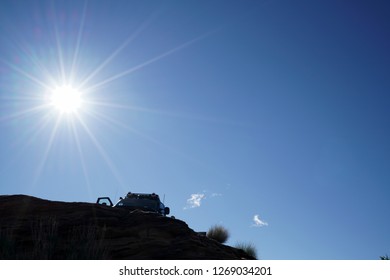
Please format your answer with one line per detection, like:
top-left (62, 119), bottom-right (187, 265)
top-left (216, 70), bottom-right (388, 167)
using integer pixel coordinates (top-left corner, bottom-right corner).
top-left (96, 192), bottom-right (170, 216)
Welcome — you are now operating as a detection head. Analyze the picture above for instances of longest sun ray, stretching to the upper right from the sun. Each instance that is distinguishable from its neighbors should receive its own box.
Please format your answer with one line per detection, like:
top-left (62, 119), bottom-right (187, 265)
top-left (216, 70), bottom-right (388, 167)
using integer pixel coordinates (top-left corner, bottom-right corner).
top-left (86, 31), bottom-right (215, 91)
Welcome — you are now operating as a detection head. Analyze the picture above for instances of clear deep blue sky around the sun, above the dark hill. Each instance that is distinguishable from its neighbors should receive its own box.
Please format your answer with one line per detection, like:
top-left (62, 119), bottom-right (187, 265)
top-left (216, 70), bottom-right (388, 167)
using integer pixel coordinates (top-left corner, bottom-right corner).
top-left (0, 0), bottom-right (390, 259)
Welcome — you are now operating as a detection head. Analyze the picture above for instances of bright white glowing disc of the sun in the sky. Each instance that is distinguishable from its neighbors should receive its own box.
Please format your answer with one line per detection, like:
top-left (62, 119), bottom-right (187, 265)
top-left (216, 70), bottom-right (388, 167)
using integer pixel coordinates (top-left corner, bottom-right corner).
top-left (50, 86), bottom-right (82, 113)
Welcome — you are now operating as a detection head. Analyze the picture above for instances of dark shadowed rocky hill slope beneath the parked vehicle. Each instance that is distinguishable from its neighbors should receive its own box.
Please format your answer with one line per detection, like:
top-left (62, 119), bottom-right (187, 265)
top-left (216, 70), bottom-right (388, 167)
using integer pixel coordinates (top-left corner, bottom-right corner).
top-left (0, 195), bottom-right (251, 260)
